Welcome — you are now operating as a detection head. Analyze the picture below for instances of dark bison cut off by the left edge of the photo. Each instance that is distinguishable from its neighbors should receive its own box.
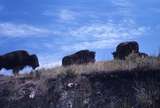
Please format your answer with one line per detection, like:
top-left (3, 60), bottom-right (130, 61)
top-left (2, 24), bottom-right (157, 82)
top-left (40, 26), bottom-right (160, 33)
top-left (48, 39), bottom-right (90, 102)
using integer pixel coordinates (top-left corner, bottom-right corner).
top-left (0, 50), bottom-right (39, 75)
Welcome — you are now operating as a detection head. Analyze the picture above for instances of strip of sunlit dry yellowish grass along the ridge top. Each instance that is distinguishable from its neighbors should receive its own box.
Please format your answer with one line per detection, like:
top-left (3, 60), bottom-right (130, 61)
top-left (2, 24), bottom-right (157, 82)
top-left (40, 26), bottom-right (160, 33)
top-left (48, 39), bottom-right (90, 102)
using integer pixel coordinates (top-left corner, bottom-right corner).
top-left (39, 54), bottom-right (160, 78)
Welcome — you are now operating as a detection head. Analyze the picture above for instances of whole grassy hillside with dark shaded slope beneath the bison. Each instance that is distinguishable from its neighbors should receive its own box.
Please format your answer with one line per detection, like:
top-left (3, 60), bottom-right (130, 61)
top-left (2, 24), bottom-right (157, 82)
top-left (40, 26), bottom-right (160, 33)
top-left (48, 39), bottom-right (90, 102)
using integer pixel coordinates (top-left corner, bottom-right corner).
top-left (0, 54), bottom-right (160, 108)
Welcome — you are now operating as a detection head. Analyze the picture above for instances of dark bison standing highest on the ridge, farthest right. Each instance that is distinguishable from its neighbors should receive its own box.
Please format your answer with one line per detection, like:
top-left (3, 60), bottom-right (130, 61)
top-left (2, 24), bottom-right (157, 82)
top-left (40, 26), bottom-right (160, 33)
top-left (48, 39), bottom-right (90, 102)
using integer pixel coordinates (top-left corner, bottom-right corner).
top-left (112, 41), bottom-right (139, 60)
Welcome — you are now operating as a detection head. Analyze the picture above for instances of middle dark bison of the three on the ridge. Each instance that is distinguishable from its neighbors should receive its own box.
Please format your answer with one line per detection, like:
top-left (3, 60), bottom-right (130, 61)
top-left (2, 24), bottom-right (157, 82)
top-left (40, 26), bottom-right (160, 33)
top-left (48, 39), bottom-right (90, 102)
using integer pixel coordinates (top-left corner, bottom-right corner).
top-left (62, 50), bottom-right (95, 66)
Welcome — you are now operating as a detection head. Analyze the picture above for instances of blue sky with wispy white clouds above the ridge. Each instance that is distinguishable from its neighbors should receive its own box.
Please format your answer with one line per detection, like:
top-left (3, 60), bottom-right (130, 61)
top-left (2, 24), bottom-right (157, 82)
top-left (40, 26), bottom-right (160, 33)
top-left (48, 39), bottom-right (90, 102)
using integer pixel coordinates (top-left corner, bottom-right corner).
top-left (0, 0), bottom-right (160, 66)
